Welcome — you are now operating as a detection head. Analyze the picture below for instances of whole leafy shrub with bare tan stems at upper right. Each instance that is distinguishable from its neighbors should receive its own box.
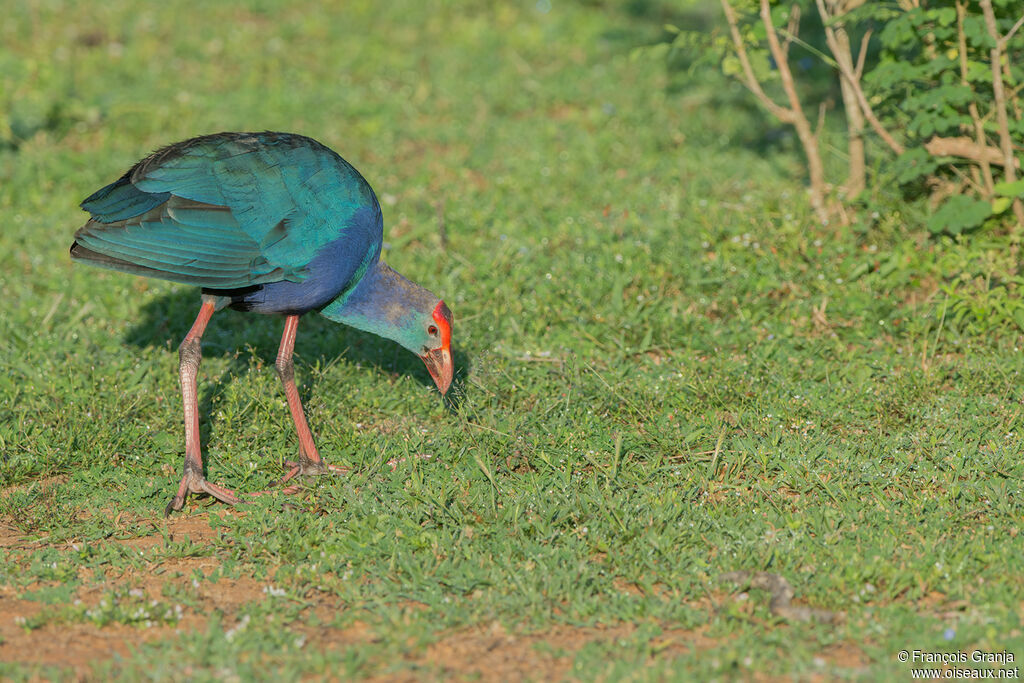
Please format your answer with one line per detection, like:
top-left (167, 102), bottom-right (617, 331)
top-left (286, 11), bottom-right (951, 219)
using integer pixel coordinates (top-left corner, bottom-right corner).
top-left (650, 0), bottom-right (1024, 234)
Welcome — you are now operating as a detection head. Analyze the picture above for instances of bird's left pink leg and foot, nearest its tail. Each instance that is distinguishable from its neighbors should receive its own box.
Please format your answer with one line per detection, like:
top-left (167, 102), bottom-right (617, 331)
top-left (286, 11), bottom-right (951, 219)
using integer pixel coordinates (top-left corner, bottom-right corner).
top-left (164, 301), bottom-right (241, 515)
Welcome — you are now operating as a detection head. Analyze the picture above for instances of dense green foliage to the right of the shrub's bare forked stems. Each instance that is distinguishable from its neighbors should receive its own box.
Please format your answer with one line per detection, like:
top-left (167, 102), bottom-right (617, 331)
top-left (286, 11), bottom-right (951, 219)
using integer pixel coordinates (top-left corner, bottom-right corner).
top-left (854, 0), bottom-right (1024, 234)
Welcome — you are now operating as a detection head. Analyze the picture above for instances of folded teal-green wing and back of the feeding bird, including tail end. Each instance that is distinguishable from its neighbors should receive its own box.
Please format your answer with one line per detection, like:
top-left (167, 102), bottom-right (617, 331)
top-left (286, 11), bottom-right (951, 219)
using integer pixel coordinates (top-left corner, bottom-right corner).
top-left (72, 133), bottom-right (381, 289)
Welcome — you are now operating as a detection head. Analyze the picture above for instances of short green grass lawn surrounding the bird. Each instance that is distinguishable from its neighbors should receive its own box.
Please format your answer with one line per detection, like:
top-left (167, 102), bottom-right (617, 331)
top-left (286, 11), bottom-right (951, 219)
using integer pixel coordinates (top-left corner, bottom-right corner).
top-left (0, 0), bottom-right (1024, 680)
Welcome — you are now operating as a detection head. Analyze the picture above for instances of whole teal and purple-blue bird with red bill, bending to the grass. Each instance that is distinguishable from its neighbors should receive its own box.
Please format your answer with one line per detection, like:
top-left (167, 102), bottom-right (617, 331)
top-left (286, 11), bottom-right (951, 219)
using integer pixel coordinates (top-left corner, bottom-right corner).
top-left (71, 131), bottom-right (454, 516)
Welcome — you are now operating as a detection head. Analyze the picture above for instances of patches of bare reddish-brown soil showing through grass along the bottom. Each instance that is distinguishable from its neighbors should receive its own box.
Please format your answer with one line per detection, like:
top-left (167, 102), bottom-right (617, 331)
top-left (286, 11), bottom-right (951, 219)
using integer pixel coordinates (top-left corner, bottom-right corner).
top-left (0, 514), bottom-right (867, 681)
